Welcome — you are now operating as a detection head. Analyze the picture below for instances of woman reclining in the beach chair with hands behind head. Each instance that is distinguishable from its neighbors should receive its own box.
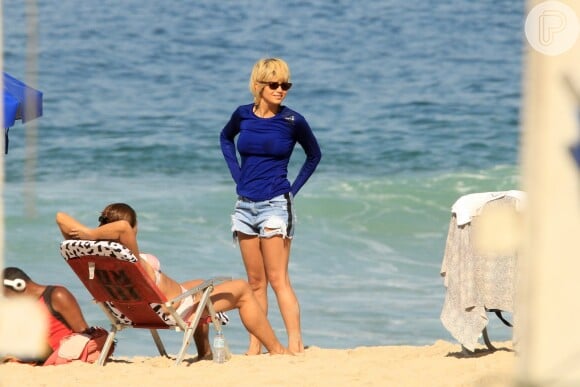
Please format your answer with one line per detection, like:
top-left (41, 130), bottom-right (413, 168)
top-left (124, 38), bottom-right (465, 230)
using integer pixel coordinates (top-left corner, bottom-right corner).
top-left (56, 203), bottom-right (290, 359)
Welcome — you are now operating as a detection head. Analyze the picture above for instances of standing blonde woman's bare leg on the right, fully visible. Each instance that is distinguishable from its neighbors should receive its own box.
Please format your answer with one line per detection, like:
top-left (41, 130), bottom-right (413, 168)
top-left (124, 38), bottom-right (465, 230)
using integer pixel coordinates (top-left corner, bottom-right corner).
top-left (261, 236), bottom-right (304, 353)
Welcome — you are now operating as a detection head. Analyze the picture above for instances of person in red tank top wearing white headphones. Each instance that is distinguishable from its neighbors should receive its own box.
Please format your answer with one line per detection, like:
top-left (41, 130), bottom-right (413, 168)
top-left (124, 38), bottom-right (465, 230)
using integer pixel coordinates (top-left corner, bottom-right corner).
top-left (3, 267), bottom-right (113, 365)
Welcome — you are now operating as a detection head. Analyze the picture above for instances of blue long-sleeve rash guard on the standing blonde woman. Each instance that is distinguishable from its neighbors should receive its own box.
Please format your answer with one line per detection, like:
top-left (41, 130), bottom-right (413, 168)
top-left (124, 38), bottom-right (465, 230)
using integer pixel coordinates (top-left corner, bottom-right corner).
top-left (220, 104), bottom-right (322, 201)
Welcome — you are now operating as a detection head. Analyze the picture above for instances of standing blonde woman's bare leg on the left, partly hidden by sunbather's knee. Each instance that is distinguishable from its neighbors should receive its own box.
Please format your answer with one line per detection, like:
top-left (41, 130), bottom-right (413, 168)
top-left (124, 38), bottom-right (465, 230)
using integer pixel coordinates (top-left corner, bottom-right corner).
top-left (237, 232), bottom-right (268, 355)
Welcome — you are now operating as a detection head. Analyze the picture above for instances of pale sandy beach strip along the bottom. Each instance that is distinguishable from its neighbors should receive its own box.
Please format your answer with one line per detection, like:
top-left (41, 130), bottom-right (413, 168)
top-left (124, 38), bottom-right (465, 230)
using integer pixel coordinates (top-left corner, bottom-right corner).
top-left (0, 341), bottom-right (516, 387)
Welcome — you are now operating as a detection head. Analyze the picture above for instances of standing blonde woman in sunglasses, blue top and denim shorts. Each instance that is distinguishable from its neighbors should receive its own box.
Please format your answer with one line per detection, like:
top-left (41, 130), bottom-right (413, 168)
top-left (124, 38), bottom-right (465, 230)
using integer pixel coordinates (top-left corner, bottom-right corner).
top-left (220, 58), bottom-right (322, 354)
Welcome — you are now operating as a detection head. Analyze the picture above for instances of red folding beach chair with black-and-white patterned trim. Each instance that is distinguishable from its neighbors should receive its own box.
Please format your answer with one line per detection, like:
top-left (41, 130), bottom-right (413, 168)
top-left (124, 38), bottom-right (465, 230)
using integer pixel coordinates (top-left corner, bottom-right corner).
top-left (60, 240), bottom-right (231, 366)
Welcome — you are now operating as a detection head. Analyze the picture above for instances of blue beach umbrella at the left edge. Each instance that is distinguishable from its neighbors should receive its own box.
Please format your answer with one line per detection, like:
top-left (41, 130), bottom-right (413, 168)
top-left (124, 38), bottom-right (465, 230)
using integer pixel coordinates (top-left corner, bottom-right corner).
top-left (3, 73), bottom-right (42, 153)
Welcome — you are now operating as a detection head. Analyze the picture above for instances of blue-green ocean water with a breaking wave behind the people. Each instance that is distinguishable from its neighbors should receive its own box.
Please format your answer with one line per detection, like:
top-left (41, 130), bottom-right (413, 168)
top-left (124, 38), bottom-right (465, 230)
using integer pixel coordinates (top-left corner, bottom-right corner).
top-left (3, 0), bottom-right (525, 356)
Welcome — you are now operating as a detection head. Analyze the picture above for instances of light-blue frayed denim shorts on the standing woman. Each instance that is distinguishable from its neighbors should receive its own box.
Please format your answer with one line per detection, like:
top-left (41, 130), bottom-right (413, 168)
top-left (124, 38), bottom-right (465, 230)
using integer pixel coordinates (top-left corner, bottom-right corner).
top-left (232, 193), bottom-right (296, 240)
